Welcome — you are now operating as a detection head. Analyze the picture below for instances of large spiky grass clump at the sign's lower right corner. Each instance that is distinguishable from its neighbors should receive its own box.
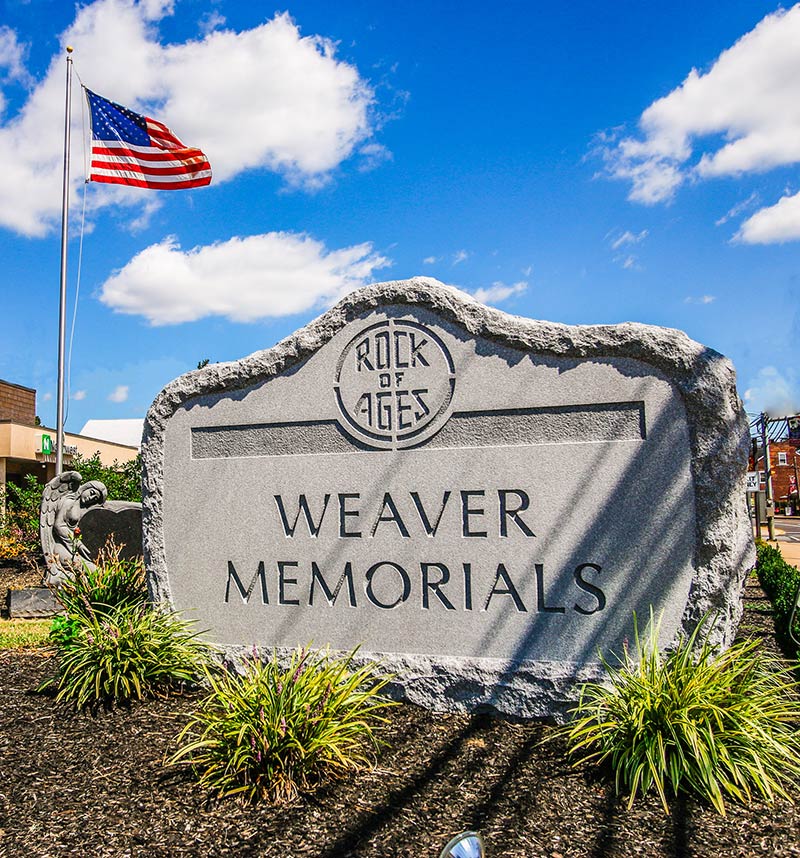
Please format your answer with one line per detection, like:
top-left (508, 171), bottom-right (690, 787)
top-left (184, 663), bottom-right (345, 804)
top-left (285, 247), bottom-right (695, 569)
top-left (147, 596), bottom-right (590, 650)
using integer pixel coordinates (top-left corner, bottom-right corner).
top-left (563, 617), bottom-right (800, 815)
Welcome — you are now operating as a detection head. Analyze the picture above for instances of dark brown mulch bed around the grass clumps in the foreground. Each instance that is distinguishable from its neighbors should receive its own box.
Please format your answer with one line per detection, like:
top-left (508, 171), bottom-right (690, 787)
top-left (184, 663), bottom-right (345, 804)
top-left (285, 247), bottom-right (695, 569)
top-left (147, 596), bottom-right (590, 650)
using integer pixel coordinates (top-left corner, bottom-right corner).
top-left (0, 568), bottom-right (800, 858)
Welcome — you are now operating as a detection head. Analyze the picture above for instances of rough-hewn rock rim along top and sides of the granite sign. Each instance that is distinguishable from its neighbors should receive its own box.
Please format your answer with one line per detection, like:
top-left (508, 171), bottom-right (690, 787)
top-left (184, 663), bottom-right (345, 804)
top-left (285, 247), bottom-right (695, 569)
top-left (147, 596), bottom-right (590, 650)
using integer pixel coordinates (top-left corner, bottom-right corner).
top-left (142, 277), bottom-right (755, 711)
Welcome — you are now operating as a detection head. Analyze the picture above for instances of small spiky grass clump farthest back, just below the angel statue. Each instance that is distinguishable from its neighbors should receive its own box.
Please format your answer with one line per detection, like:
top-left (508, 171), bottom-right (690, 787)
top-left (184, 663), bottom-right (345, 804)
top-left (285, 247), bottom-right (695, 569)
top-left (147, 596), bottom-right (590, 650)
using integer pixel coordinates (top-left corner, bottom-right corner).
top-left (52, 543), bottom-right (147, 618)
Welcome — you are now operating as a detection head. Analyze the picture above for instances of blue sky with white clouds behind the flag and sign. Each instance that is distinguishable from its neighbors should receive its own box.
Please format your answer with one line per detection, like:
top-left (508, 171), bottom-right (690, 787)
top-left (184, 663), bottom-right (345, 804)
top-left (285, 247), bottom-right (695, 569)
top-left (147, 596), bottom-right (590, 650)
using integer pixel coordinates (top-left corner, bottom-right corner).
top-left (0, 0), bottom-right (800, 431)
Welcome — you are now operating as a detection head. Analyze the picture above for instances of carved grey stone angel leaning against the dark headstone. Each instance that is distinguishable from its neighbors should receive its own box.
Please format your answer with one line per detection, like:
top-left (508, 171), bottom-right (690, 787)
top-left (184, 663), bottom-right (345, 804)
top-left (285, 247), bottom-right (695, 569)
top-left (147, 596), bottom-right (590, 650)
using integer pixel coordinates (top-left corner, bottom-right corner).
top-left (39, 471), bottom-right (108, 584)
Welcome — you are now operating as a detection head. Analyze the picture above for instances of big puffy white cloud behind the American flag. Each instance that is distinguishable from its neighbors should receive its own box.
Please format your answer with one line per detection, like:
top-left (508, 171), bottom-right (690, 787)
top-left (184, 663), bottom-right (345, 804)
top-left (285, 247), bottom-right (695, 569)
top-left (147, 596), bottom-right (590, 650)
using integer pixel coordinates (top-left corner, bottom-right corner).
top-left (0, 0), bottom-right (388, 236)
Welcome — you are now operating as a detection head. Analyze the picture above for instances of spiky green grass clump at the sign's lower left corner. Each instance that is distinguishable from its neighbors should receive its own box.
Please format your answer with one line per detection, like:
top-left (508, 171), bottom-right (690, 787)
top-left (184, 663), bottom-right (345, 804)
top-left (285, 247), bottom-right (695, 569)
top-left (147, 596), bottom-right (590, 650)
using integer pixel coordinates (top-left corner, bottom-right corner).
top-left (43, 604), bottom-right (209, 707)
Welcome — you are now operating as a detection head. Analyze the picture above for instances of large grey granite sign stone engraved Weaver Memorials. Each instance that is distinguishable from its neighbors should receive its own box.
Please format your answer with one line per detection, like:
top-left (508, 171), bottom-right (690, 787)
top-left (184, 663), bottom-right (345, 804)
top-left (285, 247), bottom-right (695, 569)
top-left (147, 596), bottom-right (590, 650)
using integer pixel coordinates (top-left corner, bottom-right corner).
top-left (143, 279), bottom-right (753, 715)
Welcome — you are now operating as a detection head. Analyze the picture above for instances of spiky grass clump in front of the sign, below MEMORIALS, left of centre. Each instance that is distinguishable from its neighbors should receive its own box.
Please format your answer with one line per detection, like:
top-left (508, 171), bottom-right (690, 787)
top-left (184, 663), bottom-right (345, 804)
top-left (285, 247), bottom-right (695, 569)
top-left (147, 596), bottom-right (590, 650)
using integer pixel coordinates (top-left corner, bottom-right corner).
top-left (170, 650), bottom-right (392, 803)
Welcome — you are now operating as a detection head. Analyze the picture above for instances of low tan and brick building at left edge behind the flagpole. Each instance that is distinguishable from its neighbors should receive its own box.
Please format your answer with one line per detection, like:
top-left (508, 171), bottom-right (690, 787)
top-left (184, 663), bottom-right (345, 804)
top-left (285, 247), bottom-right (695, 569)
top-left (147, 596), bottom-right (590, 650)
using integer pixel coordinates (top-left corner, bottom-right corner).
top-left (0, 379), bottom-right (137, 494)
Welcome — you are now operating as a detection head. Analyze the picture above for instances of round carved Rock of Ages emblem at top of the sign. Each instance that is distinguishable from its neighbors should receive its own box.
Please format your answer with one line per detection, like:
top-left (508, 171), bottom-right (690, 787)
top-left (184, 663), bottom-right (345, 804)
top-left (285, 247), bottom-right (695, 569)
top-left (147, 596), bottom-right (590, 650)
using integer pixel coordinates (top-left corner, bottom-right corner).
top-left (334, 319), bottom-right (456, 450)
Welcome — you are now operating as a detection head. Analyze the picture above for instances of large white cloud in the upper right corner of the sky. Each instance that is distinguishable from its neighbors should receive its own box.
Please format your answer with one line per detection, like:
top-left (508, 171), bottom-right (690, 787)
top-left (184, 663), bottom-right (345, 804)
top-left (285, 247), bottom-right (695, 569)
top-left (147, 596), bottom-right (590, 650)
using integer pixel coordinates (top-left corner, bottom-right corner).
top-left (597, 4), bottom-right (800, 240)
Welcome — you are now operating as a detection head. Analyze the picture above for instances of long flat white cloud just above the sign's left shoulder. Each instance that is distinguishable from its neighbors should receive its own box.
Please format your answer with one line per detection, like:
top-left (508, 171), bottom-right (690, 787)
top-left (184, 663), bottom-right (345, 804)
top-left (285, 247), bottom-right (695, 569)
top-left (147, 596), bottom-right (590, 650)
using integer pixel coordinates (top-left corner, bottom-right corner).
top-left (100, 232), bottom-right (390, 325)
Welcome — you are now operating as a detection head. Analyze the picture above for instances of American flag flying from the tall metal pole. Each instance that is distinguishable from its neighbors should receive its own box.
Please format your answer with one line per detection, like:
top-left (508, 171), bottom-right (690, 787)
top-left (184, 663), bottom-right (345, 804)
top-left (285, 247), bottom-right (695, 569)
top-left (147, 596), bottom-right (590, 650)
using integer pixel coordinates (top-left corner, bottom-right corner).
top-left (85, 89), bottom-right (211, 191)
